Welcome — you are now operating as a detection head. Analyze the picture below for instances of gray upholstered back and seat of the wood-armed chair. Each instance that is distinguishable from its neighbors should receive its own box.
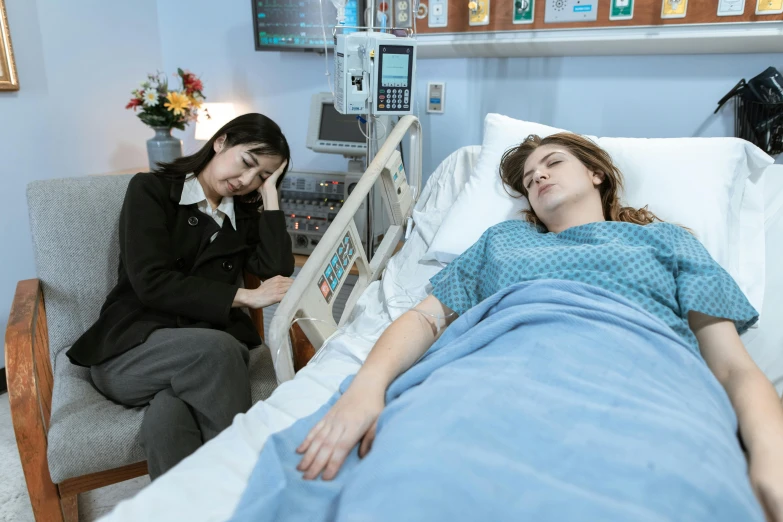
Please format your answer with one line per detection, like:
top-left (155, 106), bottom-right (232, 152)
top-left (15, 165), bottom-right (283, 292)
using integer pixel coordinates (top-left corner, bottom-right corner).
top-left (27, 175), bottom-right (277, 483)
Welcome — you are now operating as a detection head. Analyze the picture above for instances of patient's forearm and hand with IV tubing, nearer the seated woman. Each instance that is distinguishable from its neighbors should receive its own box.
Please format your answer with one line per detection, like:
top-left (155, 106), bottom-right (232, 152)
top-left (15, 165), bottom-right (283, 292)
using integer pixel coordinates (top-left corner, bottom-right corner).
top-left (297, 296), bottom-right (454, 480)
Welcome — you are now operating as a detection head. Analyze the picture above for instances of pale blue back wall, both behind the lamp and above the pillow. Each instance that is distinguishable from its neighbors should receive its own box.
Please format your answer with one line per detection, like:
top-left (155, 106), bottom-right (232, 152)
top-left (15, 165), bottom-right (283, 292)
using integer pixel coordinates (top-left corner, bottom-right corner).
top-left (158, 0), bottom-right (783, 176)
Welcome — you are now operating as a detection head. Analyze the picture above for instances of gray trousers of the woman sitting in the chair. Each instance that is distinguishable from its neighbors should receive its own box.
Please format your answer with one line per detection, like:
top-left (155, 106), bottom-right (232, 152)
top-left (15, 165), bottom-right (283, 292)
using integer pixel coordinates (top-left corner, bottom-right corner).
top-left (90, 328), bottom-right (251, 480)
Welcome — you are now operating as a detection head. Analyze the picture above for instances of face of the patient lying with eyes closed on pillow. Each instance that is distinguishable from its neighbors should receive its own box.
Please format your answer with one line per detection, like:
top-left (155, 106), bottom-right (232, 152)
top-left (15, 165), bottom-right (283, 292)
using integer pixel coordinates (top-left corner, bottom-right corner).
top-left (522, 144), bottom-right (603, 224)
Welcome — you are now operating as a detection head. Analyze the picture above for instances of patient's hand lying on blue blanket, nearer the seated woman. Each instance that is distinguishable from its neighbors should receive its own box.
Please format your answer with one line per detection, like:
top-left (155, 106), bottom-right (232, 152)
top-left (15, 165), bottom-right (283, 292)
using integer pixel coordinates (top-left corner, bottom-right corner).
top-left (296, 386), bottom-right (385, 480)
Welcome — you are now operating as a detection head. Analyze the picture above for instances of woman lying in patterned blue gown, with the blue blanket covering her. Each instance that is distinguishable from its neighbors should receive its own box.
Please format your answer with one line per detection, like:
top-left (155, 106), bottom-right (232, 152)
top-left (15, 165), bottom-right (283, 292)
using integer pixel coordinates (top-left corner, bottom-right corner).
top-left (230, 133), bottom-right (783, 522)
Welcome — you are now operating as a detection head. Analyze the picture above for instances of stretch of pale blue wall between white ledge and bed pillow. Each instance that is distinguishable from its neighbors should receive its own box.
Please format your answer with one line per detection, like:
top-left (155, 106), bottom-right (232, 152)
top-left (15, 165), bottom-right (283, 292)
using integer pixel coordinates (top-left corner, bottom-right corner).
top-left (417, 53), bottom-right (783, 169)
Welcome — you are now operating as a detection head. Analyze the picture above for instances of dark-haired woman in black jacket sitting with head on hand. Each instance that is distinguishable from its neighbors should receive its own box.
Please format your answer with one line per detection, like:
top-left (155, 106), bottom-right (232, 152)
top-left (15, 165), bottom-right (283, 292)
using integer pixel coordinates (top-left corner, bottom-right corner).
top-left (67, 114), bottom-right (294, 480)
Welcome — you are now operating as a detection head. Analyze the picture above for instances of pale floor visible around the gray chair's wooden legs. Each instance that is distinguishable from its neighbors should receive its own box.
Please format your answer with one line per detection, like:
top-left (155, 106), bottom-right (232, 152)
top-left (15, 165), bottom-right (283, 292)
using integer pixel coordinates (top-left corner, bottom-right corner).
top-left (0, 393), bottom-right (149, 522)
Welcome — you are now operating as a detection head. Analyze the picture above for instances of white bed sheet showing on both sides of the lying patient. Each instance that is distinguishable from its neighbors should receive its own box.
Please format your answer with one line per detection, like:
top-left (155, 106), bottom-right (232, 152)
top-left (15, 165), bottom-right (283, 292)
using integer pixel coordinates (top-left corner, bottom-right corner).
top-left (101, 146), bottom-right (783, 522)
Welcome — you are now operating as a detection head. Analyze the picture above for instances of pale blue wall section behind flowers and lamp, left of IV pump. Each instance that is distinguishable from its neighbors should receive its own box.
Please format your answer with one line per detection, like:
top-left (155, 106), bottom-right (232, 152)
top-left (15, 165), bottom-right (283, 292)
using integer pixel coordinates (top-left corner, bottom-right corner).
top-left (158, 0), bottom-right (347, 170)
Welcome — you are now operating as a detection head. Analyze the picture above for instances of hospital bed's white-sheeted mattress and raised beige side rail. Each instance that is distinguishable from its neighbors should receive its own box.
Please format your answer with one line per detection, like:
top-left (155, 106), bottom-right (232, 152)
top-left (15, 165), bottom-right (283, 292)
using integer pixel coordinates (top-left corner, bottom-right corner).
top-left (102, 120), bottom-right (783, 521)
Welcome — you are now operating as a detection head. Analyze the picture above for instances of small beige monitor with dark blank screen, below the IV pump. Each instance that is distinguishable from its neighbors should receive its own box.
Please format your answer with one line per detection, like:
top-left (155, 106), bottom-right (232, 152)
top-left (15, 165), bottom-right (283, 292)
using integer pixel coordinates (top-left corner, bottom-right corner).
top-left (307, 92), bottom-right (367, 157)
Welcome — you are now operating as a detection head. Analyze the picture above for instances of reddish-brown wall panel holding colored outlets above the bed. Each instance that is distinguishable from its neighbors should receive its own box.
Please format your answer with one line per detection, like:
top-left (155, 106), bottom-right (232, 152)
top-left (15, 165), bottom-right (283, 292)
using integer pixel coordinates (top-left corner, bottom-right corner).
top-left (416, 0), bottom-right (783, 34)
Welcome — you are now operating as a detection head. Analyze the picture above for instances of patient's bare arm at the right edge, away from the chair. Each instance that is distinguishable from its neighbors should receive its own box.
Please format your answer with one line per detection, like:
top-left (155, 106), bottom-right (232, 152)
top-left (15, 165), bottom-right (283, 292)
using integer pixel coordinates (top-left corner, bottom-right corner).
top-left (688, 312), bottom-right (783, 522)
